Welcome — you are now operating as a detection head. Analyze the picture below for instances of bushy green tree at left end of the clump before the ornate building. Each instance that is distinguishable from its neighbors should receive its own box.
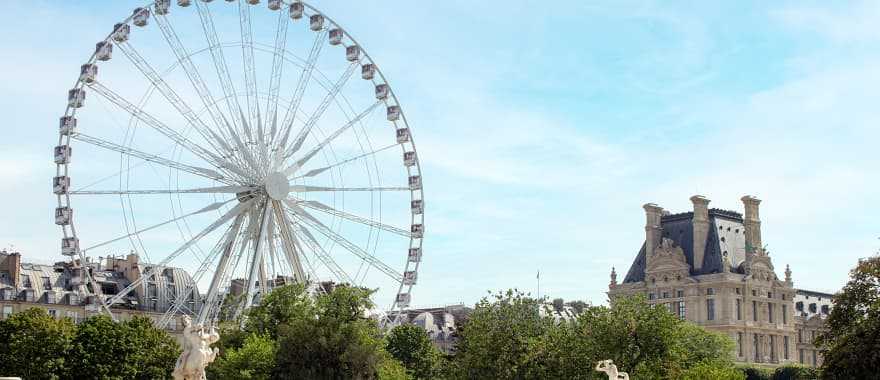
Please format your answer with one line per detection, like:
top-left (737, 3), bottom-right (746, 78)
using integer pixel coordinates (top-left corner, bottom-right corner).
top-left (455, 290), bottom-right (553, 379)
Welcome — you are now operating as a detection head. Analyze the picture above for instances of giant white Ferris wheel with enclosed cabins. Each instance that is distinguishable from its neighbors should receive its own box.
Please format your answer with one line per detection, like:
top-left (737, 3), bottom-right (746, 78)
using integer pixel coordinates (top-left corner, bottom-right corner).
top-left (53, 0), bottom-right (424, 324)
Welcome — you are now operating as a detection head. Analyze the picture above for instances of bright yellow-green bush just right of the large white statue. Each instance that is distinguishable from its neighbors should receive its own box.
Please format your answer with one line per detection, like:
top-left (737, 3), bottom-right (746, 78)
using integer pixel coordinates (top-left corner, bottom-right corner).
top-left (208, 334), bottom-right (278, 380)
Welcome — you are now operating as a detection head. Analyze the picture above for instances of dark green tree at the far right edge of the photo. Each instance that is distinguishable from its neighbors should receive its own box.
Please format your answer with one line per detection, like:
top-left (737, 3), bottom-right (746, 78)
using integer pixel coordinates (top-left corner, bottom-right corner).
top-left (816, 256), bottom-right (880, 379)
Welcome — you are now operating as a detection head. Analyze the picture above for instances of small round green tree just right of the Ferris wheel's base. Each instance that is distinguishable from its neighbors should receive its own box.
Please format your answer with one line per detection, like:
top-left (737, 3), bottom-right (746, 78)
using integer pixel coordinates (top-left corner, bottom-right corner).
top-left (385, 324), bottom-right (440, 379)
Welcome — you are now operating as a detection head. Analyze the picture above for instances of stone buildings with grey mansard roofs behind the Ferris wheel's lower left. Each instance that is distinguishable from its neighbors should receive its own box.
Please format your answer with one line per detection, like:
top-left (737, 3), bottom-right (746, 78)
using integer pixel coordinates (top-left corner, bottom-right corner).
top-left (0, 251), bottom-right (201, 333)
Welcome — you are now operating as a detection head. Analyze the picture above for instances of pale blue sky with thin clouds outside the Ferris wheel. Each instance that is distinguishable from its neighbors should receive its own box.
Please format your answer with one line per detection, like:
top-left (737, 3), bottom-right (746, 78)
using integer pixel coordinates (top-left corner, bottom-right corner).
top-left (0, 0), bottom-right (880, 305)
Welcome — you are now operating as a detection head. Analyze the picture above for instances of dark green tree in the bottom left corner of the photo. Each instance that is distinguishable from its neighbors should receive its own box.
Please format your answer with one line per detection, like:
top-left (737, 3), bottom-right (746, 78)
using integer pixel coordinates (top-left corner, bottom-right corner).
top-left (0, 308), bottom-right (75, 379)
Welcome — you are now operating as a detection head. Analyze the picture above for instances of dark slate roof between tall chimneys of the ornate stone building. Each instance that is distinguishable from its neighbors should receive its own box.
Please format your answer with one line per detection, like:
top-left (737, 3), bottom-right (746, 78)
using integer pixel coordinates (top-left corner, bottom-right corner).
top-left (623, 209), bottom-right (745, 283)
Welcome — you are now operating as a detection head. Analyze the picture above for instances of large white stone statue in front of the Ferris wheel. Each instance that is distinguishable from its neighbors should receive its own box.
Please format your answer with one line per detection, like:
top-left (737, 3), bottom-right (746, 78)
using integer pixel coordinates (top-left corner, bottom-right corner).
top-left (172, 316), bottom-right (220, 380)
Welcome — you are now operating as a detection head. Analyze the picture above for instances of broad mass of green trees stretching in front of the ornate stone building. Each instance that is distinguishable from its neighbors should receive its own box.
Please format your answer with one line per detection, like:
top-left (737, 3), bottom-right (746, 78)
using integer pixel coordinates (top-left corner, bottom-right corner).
top-left (447, 291), bottom-right (741, 379)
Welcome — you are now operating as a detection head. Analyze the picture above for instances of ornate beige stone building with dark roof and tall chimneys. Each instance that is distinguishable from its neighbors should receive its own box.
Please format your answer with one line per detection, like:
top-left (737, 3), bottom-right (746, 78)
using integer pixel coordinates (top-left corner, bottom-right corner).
top-left (608, 195), bottom-right (798, 365)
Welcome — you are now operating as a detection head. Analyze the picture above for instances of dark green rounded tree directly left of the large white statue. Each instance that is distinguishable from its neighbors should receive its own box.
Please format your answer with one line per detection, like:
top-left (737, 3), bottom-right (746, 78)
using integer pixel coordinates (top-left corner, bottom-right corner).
top-left (68, 315), bottom-right (180, 380)
